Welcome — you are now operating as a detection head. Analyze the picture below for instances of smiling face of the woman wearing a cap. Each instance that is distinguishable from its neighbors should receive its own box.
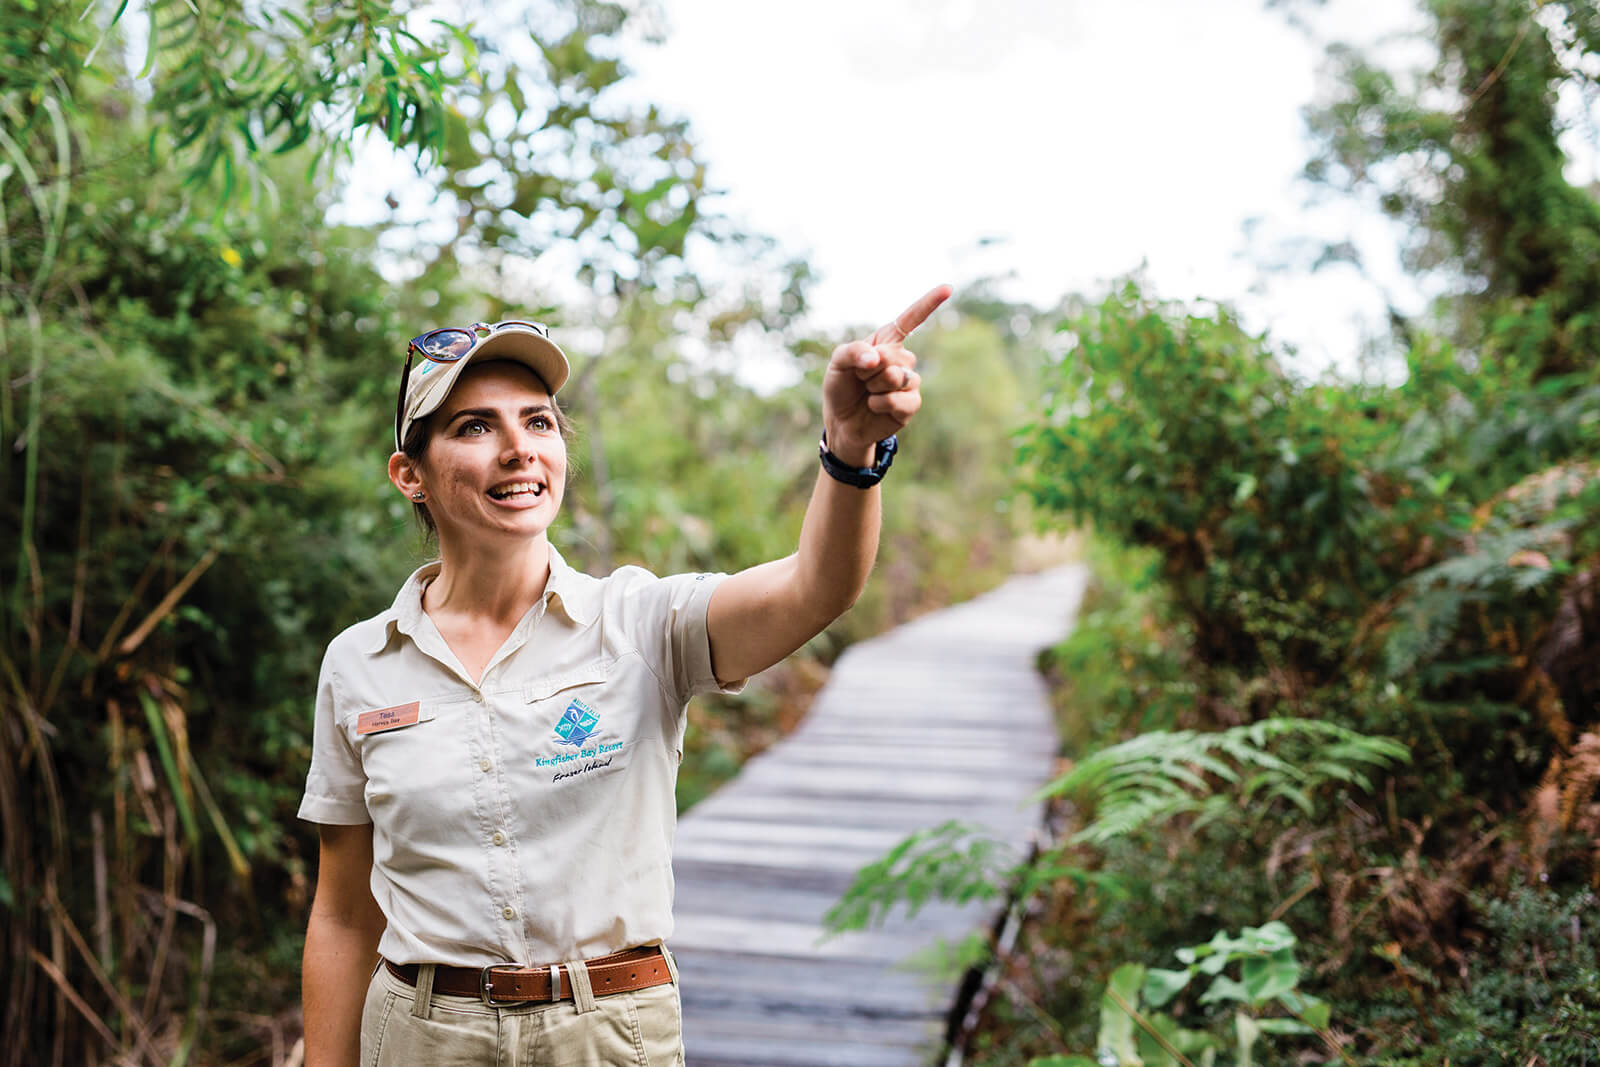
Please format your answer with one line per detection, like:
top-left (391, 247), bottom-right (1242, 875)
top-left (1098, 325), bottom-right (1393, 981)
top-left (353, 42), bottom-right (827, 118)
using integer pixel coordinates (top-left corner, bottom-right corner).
top-left (406, 362), bottom-right (566, 545)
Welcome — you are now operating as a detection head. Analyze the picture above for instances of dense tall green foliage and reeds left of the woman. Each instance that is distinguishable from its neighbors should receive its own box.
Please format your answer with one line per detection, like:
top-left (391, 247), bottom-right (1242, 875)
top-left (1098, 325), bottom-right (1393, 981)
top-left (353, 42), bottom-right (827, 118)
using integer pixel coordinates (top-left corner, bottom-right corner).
top-left (0, 85), bottom-right (405, 1056)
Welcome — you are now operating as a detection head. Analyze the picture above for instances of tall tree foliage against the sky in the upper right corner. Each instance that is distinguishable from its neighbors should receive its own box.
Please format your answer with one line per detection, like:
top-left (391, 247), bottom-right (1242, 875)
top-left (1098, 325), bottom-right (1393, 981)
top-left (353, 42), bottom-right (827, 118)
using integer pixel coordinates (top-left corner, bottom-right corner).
top-left (1307, 0), bottom-right (1600, 378)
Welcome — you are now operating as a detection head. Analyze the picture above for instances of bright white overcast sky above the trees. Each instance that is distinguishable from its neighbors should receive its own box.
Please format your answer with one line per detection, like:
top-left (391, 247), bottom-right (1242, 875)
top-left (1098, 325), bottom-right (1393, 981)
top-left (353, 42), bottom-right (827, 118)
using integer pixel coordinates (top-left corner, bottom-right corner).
top-left (632, 0), bottom-right (1410, 371)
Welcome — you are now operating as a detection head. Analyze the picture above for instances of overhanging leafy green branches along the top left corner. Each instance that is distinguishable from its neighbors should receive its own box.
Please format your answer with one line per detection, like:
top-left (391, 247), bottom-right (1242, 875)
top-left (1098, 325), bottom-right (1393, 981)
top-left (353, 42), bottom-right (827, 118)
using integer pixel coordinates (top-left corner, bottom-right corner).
top-left (0, 0), bottom-right (475, 213)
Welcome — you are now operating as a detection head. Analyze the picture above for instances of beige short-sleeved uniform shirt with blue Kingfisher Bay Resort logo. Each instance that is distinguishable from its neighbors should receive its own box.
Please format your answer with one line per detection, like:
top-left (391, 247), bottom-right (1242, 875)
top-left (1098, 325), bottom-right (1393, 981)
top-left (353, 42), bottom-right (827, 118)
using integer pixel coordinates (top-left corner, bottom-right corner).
top-left (299, 549), bottom-right (742, 966)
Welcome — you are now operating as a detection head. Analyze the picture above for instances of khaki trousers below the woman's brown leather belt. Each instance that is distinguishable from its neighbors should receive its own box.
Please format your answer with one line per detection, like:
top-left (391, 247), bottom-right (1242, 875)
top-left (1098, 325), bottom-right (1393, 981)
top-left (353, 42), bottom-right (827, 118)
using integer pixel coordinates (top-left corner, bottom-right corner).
top-left (362, 949), bottom-right (683, 1067)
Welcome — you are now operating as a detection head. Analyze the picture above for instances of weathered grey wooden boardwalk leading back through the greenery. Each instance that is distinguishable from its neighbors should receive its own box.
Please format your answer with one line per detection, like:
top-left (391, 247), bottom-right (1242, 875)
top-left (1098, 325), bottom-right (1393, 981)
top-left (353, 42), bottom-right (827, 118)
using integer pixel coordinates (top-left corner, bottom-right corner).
top-left (670, 566), bottom-right (1085, 1067)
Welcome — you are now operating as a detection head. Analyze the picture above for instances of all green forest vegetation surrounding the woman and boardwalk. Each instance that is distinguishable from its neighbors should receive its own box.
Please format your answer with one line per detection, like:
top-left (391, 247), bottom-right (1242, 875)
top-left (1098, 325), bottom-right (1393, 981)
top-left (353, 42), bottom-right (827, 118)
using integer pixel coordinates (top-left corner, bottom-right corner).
top-left (0, 0), bottom-right (1600, 1064)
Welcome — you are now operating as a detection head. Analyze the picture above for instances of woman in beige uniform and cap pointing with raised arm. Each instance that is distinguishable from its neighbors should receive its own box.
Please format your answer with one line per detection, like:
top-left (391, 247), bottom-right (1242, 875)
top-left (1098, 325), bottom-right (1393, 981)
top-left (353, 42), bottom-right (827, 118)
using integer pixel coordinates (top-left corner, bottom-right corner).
top-left (301, 286), bottom-right (950, 1067)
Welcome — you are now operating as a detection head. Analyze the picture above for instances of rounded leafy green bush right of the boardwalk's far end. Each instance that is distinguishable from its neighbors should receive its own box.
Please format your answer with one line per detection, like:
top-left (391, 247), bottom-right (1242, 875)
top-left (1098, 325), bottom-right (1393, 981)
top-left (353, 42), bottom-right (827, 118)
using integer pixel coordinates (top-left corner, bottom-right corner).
top-left (1019, 283), bottom-right (1381, 672)
